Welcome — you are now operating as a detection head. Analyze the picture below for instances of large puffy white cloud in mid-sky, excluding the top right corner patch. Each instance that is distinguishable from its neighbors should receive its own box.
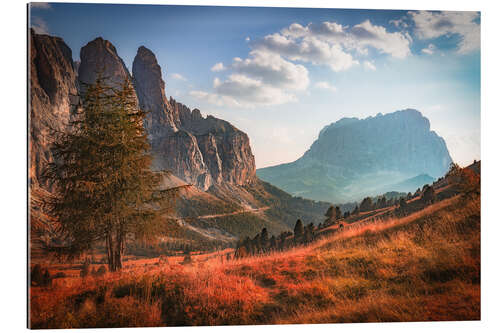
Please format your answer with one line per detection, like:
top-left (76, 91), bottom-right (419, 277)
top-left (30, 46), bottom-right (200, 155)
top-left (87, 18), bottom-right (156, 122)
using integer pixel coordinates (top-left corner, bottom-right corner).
top-left (201, 20), bottom-right (411, 107)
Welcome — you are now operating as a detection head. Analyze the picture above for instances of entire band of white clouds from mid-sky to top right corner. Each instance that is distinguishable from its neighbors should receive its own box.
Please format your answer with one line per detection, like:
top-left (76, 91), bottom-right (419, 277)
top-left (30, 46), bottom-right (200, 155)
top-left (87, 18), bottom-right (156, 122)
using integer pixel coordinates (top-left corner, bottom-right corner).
top-left (190, 11), bottom-right (480, 107)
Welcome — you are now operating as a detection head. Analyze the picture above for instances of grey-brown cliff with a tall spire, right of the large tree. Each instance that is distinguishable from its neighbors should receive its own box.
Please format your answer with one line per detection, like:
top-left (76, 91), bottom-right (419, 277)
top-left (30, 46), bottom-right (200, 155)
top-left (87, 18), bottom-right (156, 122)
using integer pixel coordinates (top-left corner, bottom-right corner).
top-left (132, 46), bottom-right (255, 190)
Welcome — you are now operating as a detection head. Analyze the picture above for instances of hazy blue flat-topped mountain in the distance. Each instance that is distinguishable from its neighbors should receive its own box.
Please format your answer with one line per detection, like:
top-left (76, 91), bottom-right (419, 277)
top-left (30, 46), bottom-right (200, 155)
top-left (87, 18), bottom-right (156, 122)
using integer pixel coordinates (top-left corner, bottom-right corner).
top-left (257, 109), bottom-right (452, 203)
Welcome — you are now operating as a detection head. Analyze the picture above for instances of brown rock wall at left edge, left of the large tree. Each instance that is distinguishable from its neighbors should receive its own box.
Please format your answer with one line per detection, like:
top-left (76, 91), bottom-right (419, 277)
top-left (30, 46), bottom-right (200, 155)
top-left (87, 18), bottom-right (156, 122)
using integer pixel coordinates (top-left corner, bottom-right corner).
top-left (28, 30), bottom-right (78, 191)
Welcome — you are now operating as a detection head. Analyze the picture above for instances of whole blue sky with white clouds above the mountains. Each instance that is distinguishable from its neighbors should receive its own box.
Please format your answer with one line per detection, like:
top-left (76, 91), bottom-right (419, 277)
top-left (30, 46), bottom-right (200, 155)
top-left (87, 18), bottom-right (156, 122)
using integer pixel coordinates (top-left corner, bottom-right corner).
top-left (30, 3), bottom-right (481, 168)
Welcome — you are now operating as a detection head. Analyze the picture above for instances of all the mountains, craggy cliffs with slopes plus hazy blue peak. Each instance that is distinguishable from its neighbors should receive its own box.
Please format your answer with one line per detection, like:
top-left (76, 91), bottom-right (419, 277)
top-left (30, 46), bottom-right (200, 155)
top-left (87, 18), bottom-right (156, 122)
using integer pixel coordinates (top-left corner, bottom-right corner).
top-left (29, 30), bottom-right (451, 243)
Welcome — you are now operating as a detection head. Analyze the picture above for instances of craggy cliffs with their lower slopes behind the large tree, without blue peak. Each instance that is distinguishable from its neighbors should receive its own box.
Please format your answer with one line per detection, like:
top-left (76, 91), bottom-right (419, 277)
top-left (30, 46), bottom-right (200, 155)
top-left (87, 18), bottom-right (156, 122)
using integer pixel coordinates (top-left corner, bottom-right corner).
top-left (28, 30), bottom-right (329, 248)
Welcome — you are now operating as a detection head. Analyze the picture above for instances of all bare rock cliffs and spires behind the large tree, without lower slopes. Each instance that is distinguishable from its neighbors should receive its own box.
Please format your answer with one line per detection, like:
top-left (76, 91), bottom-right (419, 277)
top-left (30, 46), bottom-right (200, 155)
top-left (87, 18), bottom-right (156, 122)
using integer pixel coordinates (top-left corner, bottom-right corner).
top-left (29, 31), bottom-right (256, 191)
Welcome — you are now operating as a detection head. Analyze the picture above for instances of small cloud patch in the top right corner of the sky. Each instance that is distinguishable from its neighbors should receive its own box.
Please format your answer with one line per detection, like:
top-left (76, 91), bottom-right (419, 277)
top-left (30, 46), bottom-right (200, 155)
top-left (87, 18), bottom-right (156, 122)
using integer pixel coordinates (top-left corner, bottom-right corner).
top-left (409, 11), bottom-right (481, 53)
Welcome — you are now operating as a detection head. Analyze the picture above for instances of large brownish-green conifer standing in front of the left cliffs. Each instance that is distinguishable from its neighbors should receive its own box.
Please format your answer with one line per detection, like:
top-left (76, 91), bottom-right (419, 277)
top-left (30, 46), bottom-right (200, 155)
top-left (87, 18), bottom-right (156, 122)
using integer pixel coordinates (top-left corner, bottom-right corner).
top-left (44, 74), bottom-right (176, 271)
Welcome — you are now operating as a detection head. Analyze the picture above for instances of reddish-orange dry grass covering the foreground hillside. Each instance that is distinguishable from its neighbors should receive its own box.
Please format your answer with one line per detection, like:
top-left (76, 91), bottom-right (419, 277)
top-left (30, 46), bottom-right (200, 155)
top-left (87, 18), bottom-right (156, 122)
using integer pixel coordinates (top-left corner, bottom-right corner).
top-left (31, 192), bottom-right (480, 328)
